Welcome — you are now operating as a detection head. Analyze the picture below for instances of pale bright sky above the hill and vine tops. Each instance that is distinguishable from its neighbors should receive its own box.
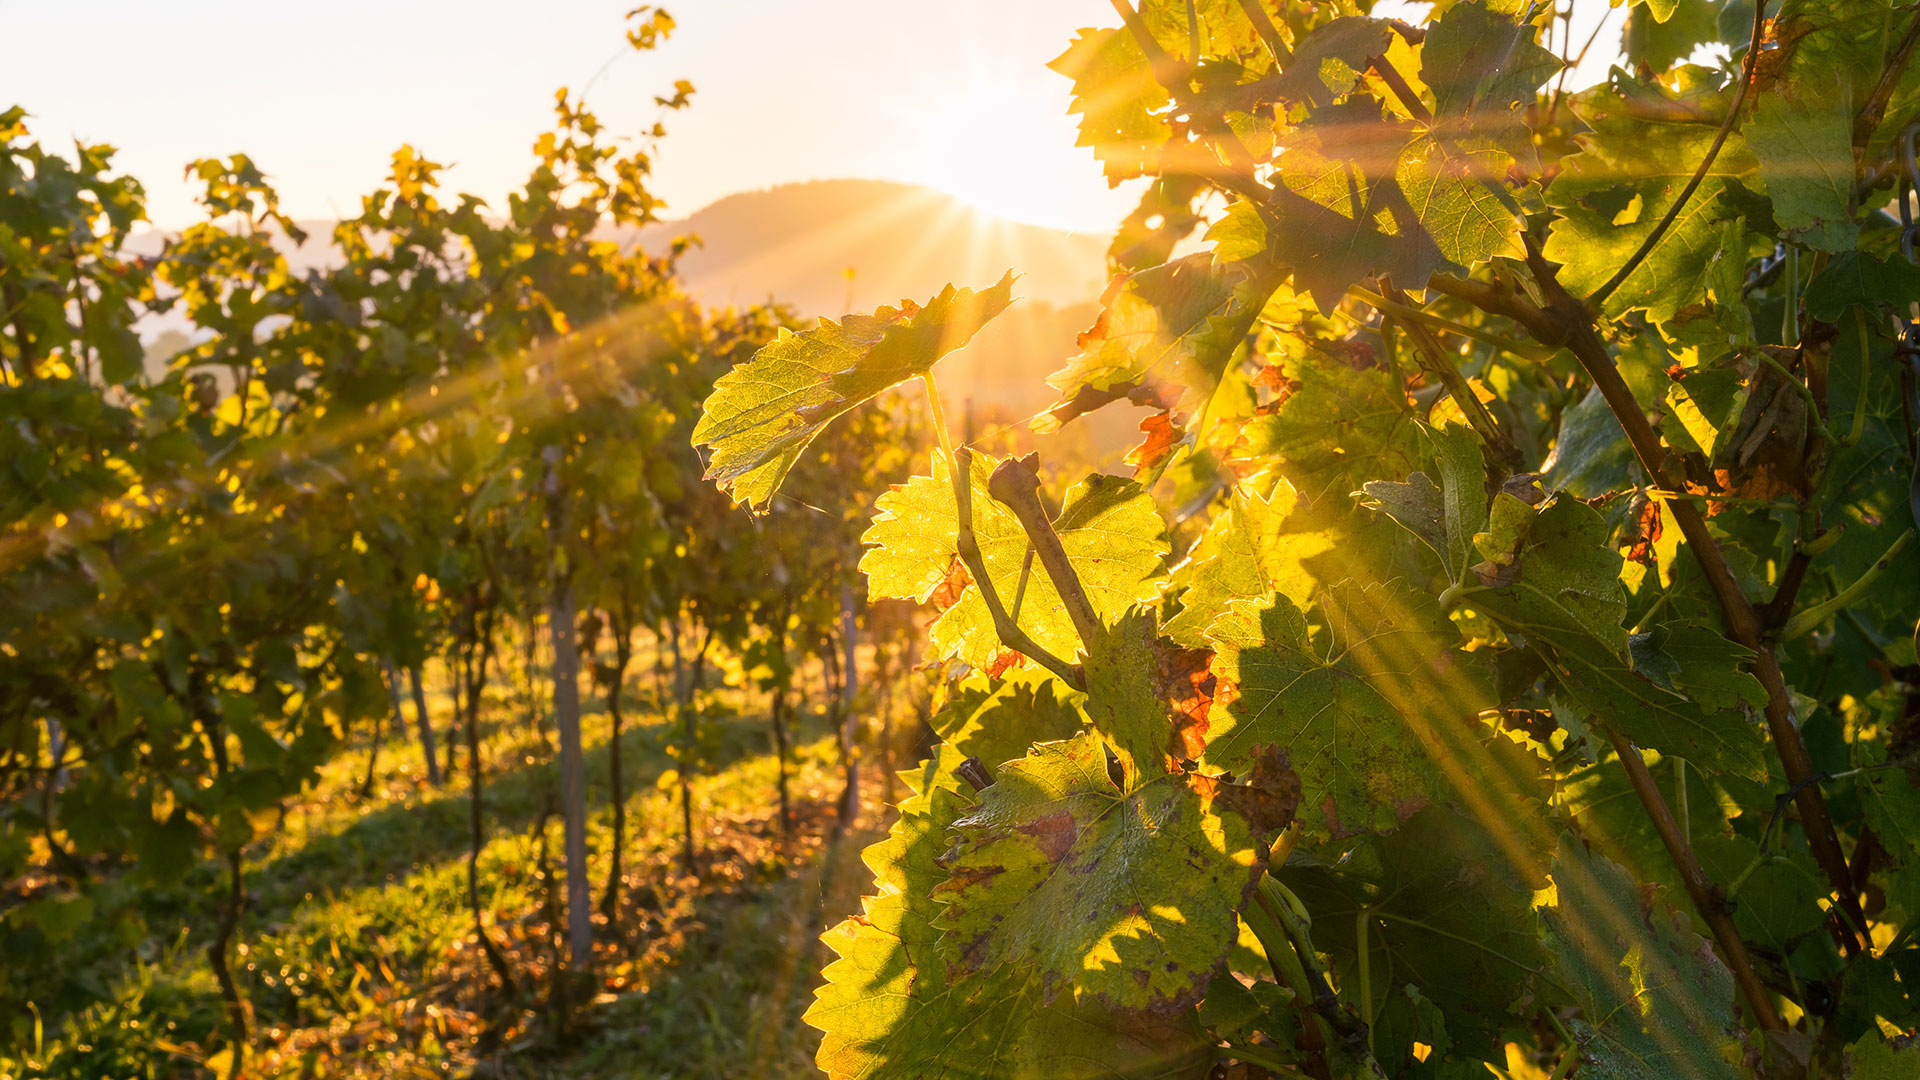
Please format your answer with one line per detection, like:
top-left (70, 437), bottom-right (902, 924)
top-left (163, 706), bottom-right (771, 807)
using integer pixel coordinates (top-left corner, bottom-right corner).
top-left (0, 0), bottom-right (1611, 233)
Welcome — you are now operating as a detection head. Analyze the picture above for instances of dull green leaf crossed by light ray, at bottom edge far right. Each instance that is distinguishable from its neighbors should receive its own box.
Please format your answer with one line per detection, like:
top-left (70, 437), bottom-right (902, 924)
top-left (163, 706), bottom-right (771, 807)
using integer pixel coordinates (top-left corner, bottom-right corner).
top-left (1542, 838), bottom-right (1743, 1080)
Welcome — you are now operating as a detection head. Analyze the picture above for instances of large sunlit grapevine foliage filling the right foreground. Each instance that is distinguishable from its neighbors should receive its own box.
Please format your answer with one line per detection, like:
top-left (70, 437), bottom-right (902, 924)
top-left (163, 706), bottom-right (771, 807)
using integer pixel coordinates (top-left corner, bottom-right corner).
top-left (695, 0), bottom-right (1920, 1078)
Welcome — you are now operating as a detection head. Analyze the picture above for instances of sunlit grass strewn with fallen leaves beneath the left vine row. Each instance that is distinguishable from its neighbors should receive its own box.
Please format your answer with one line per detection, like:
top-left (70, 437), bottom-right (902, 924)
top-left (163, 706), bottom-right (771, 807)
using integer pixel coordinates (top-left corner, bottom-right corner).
top-left (0, 641), bottom-right (906, 1080)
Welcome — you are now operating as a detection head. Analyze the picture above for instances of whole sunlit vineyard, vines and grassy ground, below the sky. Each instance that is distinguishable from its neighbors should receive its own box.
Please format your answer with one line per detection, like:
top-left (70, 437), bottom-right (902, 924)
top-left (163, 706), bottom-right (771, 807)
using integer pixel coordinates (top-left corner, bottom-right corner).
top-left (0, 0), bottom-right (1920, 1080)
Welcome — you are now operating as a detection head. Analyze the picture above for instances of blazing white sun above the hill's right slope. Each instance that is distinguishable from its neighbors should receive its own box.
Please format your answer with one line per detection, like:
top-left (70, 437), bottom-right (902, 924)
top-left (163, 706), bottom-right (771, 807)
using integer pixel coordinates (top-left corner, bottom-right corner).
top-left (902, 71), bottom-right (1131, 231)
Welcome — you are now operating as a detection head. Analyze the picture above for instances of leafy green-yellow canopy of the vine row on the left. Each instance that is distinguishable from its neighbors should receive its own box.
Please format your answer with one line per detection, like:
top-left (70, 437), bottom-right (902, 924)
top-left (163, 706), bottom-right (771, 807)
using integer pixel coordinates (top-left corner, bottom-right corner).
top-left (0, 8), bottom-right (913, 1074)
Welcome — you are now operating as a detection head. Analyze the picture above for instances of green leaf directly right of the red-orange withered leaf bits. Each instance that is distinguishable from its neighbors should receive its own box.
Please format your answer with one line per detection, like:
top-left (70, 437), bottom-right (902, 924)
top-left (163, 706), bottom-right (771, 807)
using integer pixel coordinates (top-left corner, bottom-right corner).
top-left (1202, 598), bottom-right (1436, 838)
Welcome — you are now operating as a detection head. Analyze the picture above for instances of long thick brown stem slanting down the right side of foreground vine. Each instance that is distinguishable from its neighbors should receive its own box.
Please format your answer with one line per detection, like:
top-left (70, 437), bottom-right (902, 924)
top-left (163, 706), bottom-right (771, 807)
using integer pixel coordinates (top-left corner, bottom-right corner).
top-left (1505, 236), bottom-right (1866, 951)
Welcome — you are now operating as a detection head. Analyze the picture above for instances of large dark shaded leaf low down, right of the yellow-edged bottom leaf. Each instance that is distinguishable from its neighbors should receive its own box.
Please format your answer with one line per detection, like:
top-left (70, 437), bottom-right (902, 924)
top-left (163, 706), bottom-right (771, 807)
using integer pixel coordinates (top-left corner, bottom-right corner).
top-left (1279, 805), bottom-right (1551, 1061)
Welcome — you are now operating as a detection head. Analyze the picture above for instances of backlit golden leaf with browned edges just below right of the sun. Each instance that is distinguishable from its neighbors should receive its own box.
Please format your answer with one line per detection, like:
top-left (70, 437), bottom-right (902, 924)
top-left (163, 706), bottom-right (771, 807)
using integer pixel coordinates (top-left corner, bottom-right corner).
top-left (1035, 252), bottom-right (1279, 430)
